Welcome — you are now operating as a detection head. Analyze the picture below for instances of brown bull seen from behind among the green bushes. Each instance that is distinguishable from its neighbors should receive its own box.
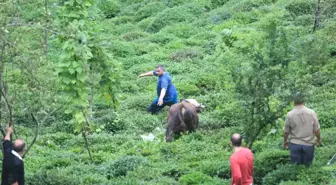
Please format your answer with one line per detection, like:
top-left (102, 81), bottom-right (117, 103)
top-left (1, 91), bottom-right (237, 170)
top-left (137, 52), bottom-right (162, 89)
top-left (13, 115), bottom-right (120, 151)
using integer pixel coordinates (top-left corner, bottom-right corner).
top-left (166, 101), bottom-right (198, 142)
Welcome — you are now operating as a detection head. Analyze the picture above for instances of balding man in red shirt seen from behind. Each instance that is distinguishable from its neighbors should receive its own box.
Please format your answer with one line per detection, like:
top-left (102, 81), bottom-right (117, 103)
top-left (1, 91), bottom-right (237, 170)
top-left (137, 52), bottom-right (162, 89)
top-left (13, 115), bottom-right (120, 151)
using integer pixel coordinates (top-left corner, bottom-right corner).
top-left (230, 134), bottom-right (253, 185)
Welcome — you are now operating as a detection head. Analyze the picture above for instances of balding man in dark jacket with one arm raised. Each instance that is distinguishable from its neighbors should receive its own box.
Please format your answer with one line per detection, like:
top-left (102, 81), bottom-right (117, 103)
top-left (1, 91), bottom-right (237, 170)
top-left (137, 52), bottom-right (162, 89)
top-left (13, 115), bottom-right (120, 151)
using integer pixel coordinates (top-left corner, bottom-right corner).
top-left (1, 126), bottom-right (25, 185)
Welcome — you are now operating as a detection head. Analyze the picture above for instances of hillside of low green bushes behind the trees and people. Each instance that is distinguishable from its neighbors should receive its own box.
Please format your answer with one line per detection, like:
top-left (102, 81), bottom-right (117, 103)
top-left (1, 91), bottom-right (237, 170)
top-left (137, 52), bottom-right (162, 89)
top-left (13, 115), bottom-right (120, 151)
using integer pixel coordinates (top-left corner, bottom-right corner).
top-left (0, 0), bottom-right (336, 185)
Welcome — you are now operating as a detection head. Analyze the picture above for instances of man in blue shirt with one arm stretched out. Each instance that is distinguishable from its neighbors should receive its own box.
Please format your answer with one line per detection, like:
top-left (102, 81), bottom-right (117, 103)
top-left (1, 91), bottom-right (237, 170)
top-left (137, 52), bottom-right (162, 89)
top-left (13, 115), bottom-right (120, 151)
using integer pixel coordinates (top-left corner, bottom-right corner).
top-left (138, 65), bottom-right (178, 114)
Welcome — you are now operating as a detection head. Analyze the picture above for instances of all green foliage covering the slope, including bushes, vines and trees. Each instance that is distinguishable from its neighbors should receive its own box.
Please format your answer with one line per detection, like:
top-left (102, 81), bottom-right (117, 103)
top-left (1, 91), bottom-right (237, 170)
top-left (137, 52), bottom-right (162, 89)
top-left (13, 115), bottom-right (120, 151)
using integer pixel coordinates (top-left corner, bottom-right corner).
top-left (0, 0), bottom-right (336, 185)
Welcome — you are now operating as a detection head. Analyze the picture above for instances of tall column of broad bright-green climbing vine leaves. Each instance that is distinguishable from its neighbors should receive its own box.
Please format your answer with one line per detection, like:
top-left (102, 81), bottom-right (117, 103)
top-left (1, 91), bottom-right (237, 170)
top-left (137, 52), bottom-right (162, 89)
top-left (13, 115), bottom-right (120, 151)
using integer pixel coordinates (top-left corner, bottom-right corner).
top-left (56, 0), bottom-right (120, 132)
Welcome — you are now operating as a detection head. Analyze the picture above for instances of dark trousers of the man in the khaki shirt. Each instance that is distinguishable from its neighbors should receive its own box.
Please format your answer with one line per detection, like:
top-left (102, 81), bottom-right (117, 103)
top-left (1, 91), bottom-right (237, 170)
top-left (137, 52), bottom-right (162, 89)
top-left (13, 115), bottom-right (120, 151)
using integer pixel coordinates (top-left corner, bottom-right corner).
top-left (289, 143), bottom-right (314, 165)
